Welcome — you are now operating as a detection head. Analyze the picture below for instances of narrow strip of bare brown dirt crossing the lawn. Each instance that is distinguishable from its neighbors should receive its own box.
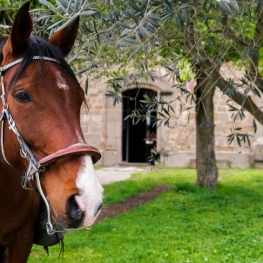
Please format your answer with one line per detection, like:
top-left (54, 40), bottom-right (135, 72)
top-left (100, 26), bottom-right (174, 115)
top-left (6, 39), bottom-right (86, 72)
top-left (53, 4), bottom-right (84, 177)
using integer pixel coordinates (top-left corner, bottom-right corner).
top-left (96, 185), bottom-right (171, 222)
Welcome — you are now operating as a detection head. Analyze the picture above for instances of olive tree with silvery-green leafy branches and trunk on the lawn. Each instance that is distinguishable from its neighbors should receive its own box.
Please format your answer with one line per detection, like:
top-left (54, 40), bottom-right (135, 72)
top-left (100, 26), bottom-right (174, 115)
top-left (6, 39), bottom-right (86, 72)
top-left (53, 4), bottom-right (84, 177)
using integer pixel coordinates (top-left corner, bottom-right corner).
top-left (2, 0), bottom-right (263, 189)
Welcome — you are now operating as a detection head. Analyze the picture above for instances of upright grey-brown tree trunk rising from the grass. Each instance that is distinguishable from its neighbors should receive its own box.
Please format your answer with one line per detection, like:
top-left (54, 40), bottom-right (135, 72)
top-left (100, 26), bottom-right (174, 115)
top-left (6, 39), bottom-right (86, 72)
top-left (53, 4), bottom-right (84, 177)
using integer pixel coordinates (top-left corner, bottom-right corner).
top-left (195, 69), bottom-right (218, 190)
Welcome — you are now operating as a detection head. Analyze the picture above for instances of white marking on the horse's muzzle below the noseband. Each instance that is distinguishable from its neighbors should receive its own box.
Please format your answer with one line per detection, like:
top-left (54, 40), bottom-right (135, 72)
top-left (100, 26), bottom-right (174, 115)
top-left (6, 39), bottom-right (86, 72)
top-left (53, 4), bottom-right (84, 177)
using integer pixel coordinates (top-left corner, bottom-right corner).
top-left (75, 156), bottom-right (103, 227)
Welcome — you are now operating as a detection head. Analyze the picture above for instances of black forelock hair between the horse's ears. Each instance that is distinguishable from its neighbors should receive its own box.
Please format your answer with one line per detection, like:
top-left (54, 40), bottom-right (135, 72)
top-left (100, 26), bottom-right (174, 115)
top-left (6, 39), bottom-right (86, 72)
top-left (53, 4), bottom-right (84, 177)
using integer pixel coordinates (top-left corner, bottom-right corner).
top-left (0, 35), bottom-right (78, 91)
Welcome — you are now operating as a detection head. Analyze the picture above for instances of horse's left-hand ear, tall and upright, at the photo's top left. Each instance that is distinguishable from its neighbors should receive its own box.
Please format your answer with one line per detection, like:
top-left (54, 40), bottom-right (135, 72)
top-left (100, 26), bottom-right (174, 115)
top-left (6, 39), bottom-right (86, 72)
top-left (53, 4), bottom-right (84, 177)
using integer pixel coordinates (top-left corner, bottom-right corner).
top-left (4, 2), bottom-right (33, 55)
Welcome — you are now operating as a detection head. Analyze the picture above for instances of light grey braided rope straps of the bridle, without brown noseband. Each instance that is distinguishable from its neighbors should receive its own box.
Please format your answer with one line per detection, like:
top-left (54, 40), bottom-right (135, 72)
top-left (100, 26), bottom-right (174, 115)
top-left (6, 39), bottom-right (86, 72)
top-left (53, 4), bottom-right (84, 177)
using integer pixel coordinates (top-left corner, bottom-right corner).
top-left (0, 56), bottom-right (59, 235)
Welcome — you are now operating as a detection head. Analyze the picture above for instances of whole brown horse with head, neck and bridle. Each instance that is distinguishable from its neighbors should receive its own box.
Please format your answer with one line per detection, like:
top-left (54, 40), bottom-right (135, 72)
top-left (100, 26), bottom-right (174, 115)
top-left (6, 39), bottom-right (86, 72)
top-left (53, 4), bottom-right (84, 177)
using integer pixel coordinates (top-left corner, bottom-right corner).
top-left (0, 2), bottom-right (103, 263)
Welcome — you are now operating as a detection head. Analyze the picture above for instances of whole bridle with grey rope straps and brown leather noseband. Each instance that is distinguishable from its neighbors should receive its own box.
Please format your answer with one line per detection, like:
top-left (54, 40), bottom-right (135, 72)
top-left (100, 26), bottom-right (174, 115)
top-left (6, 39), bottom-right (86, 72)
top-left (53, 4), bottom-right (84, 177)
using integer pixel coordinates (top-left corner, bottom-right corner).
top-left (0, 56), bottom-right (101, 235)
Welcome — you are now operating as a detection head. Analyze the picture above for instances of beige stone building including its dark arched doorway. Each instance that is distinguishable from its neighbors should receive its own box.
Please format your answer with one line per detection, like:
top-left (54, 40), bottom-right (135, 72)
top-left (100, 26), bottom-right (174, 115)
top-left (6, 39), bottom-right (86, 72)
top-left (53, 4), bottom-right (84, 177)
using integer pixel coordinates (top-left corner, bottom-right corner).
top-left (81, 66), bottom-right (263, 168)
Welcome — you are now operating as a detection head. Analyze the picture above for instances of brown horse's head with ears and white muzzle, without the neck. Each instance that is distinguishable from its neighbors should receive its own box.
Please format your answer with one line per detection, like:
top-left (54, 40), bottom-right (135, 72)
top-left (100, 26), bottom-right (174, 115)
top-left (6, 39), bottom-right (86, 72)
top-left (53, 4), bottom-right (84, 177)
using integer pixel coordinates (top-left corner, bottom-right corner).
top-left (0, 2), bottom-right (103, 235)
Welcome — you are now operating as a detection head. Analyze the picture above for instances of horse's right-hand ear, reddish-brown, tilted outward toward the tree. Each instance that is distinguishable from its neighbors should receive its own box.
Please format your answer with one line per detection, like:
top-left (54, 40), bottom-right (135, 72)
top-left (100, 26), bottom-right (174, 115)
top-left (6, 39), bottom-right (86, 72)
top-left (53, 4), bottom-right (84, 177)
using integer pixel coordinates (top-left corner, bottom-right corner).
top-left (49, 17), bottom-right (79, 57)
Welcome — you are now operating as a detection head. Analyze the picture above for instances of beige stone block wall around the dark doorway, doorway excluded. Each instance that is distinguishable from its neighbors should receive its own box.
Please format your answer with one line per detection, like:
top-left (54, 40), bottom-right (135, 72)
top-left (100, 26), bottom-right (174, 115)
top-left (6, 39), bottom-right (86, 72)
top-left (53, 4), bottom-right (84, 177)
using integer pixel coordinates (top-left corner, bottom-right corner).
top-left (81, 66), bottom-right (263, 167)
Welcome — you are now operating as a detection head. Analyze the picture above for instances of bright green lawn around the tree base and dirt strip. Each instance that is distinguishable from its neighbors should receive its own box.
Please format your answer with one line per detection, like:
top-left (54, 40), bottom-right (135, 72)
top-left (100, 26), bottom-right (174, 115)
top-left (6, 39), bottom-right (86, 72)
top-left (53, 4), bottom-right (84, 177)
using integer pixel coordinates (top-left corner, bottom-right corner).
top-left (29, 169), bottom-right (263, 263)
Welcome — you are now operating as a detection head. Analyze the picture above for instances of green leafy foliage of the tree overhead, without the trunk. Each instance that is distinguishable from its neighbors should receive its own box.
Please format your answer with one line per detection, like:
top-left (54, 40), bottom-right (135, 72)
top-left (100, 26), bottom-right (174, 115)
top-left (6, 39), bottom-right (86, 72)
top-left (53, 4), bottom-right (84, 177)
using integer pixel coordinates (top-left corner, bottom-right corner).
top-left (1, 0), bottom-right (263, 146)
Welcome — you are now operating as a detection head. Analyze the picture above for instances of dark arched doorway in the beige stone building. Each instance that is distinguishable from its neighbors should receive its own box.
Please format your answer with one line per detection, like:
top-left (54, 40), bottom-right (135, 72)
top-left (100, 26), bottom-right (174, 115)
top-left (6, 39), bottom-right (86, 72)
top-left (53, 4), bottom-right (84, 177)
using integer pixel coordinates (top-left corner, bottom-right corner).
top-left (122, 88), bottom-right (157, 163)
